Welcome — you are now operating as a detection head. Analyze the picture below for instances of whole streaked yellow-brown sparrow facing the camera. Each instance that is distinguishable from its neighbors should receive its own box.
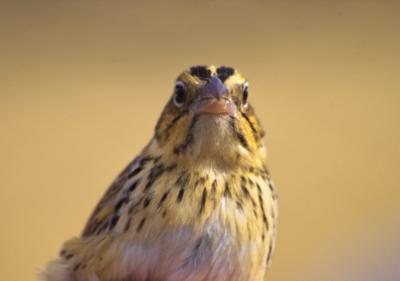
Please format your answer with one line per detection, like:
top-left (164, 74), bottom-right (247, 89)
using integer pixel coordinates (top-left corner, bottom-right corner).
top-left (41, 65), bottom-right (277, 281)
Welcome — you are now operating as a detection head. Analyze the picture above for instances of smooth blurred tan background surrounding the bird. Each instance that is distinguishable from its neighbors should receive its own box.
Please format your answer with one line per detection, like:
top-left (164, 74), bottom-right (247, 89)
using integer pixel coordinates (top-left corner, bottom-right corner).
top-left (0, 0), bottom-right (400, 281)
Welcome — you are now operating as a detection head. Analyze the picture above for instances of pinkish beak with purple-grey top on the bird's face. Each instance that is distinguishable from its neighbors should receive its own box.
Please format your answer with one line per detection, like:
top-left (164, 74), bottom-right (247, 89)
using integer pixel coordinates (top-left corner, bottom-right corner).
top-left (191, 77), bottom-right (237, 116)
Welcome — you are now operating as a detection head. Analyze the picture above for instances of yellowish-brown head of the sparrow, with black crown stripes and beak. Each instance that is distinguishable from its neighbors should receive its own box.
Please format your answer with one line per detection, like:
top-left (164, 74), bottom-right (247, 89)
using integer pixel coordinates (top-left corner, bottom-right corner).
top-left (156, 66), bottom-right (264, 166)
